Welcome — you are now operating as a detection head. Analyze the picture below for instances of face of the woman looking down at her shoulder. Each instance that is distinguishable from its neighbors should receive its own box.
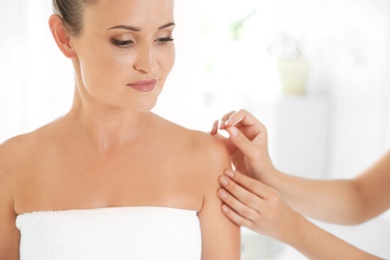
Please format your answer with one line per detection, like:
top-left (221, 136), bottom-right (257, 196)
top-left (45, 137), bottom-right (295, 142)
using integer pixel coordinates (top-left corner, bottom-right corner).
top-left (72, 0), bottom-right (175, 111)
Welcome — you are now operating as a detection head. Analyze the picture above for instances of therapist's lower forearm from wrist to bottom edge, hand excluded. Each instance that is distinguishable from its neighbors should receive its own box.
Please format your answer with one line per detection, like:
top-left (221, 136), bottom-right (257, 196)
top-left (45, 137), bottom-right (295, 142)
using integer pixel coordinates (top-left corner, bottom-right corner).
top-left (284, 215), bottom-right (379, 259)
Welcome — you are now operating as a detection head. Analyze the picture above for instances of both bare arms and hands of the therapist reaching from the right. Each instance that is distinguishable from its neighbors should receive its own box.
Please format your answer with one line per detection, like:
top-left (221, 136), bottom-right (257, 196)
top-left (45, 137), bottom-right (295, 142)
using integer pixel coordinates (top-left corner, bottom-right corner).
top-left (211, 110), bottom-right (390, 259)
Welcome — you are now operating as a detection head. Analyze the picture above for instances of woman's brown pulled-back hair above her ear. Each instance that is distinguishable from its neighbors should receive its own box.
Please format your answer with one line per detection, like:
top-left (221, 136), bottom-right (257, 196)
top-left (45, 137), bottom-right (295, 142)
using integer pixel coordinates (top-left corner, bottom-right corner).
top-left (53, 0), bottom-right (98, 36)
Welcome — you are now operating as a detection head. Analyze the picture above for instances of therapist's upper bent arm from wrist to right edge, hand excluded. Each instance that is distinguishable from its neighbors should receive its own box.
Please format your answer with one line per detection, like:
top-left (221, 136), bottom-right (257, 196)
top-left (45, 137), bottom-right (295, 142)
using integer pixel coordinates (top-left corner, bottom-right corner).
top-left (267, 152), bottom-right (390, 224)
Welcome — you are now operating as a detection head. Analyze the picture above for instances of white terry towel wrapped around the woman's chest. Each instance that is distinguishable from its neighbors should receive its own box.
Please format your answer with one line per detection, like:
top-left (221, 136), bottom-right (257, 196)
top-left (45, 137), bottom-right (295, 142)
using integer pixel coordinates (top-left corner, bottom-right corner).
top-left (16, 207), bottom-right (201, 260)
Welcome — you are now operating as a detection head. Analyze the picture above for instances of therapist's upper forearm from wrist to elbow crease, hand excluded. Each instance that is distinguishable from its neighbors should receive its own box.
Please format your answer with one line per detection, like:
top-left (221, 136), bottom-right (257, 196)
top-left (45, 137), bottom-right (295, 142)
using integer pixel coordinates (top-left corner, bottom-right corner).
top-left (265, 172), bottom-right (365, 224)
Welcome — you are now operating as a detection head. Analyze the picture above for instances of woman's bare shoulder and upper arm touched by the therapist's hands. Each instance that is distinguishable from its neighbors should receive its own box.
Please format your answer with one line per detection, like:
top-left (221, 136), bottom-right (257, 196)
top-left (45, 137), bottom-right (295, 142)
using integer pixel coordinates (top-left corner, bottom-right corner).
top-left (161, 121), bottom-right (240, 259)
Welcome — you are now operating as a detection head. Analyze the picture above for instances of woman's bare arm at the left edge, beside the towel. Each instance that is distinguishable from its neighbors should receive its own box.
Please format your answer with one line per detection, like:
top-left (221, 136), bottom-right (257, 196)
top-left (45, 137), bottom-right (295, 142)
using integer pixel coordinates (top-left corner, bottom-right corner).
top-left (0, 142), bottom-right (20, 260)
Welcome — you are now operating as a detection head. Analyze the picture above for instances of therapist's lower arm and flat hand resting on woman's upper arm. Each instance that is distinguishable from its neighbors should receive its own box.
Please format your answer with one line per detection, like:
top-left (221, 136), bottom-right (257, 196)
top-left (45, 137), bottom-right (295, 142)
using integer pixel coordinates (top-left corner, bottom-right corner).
top-left (218, 171), bottom-right (379, 260)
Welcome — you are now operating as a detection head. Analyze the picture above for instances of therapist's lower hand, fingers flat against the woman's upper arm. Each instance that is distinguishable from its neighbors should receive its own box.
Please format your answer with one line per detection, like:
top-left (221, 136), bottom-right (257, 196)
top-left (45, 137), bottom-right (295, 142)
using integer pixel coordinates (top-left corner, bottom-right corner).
top-left (218, 170), bottom-right (306, 242)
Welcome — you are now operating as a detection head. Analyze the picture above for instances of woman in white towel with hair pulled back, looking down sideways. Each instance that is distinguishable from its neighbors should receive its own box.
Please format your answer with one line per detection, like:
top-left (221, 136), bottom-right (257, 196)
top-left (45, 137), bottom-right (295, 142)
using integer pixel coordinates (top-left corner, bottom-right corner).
top-left (0, 0), bottom-right (240, 260)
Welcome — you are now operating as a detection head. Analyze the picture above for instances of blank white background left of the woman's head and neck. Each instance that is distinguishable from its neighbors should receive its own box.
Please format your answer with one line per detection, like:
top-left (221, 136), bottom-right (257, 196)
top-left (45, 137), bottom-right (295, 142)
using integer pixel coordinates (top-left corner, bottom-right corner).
top-left (0, 0), bottom-right (73, 142)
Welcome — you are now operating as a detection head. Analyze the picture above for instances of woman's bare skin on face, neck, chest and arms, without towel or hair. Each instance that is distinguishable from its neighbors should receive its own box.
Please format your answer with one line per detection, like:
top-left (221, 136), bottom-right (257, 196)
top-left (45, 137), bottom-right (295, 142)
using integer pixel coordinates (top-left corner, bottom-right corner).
top-left (0, 0), bottom-right (240, 260)
